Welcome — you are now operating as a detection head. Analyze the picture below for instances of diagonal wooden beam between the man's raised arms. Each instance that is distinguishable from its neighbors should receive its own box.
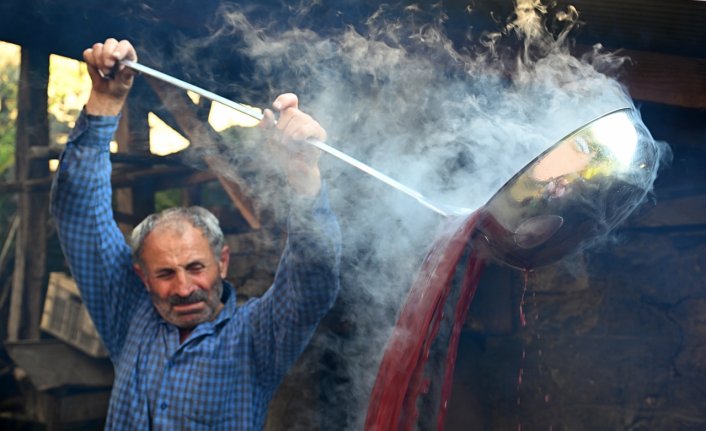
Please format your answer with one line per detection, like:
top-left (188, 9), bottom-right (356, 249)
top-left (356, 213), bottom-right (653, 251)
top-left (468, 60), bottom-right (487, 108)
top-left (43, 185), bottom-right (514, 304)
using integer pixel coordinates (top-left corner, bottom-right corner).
top-left (145, 77), bottom-right (262, 229)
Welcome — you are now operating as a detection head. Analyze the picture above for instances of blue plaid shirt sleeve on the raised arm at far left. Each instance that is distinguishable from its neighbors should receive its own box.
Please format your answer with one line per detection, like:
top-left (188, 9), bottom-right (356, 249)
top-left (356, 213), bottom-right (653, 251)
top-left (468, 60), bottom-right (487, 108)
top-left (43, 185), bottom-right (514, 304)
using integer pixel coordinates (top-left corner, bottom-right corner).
top-left (51, 112), bottom-right (146, 359)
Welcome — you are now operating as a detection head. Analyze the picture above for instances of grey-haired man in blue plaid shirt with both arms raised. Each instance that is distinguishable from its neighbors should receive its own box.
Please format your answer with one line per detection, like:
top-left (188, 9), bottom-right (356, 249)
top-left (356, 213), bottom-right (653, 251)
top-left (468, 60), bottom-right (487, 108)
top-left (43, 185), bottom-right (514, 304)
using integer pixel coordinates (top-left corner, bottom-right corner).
top-left (51, 39), bottom-right (340, 431)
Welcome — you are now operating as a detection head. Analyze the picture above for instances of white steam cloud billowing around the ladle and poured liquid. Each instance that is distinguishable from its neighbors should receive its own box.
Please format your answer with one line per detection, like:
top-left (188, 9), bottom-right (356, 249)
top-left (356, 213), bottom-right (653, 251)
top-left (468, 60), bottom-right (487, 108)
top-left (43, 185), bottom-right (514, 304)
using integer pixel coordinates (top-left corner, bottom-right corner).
top-left (147, 0), bottom-right (664, 429)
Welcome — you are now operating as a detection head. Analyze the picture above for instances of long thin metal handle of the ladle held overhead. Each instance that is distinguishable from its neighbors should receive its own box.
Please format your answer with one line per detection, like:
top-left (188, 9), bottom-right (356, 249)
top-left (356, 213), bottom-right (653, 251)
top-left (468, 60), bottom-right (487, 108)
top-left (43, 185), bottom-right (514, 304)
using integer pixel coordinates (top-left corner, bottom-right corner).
top-left (120, 60), bottom-right (462, 216)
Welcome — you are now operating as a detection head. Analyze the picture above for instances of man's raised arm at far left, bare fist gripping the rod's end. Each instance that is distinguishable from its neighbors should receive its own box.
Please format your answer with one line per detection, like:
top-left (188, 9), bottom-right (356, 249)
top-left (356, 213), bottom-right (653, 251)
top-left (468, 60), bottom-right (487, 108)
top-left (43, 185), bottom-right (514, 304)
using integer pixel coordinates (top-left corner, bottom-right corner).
top-left (51, 39), bottom-right (145, 356)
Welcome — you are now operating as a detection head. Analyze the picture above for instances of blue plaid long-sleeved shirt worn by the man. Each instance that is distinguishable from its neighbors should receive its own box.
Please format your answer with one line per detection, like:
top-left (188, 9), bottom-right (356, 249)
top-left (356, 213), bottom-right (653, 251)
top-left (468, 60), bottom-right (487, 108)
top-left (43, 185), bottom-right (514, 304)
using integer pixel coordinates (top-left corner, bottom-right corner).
top-left (51, 109), bottom-right (341, 431)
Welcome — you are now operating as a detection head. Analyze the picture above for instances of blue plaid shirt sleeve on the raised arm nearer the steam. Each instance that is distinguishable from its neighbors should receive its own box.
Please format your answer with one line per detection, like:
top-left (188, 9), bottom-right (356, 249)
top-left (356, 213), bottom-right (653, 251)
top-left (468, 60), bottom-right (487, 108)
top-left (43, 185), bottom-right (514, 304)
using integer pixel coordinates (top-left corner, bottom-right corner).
top-left (250, 184), bottom-right (341, 390)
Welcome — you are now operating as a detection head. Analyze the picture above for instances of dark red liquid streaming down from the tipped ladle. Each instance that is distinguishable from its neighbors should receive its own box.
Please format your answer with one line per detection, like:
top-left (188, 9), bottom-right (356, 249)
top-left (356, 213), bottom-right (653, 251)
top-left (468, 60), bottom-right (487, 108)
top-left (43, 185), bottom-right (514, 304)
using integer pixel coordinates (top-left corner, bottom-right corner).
top-left (365, 212), bottom-right (485, 431)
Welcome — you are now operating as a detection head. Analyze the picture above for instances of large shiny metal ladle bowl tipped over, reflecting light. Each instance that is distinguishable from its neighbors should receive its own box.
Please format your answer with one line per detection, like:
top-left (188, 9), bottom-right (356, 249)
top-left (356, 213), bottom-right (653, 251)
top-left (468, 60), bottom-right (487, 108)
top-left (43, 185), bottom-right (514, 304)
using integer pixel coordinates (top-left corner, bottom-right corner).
top-left (473, 108), bottom-right (659, 269)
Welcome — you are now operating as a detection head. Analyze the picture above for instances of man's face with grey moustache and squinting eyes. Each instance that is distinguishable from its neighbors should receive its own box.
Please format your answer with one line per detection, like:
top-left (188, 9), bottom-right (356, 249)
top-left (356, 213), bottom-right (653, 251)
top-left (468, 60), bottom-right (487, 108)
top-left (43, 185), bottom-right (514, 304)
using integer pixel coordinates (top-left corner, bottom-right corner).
top-left (135, 222), bottom-right (229, 329)
